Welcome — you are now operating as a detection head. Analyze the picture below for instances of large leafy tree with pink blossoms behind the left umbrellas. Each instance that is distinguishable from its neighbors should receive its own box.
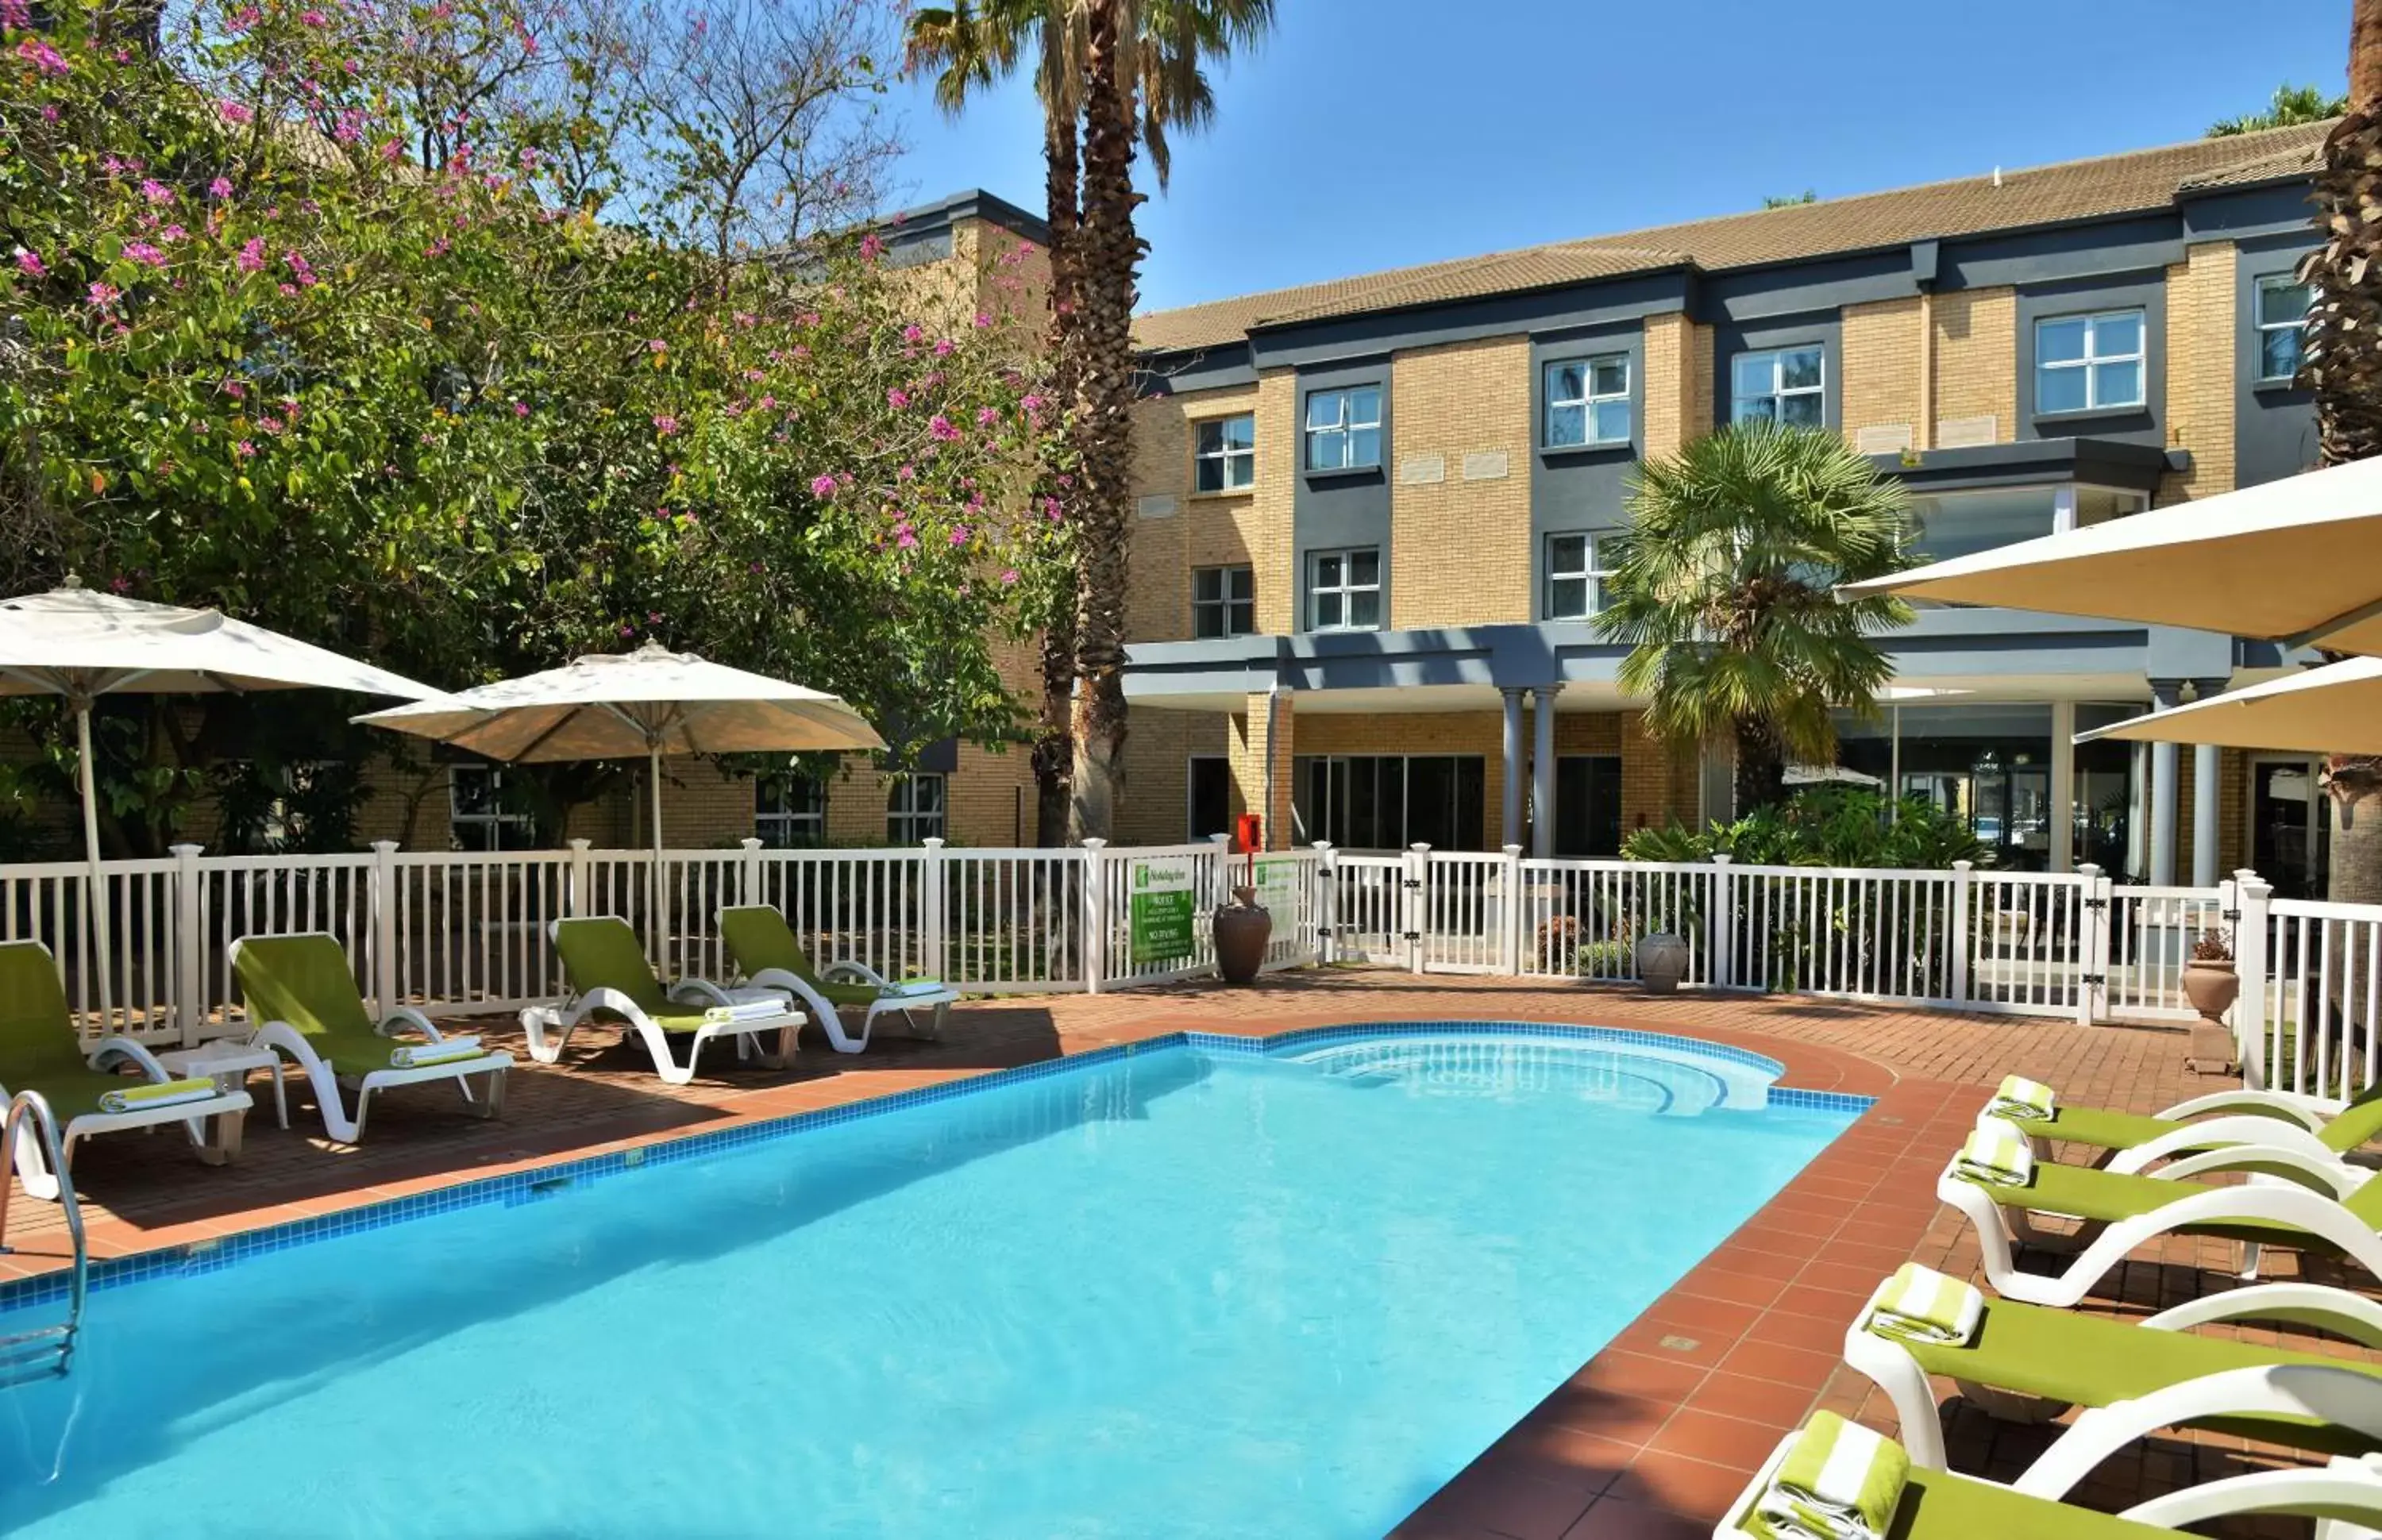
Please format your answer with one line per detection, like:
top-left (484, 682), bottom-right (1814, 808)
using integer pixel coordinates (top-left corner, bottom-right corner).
top-left (0, 0), bottom-right (1058, 847)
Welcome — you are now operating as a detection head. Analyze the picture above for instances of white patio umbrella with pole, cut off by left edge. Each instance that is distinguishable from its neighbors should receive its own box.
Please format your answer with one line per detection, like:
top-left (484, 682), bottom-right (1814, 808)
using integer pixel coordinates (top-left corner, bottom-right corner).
top-left (0, 576), bottom-right (436, 1018)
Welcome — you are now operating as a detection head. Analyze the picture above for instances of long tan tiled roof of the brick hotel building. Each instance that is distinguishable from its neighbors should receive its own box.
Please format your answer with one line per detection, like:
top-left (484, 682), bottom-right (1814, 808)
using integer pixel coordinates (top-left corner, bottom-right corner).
top-left (1134, 121), bottom-right (2332, 352)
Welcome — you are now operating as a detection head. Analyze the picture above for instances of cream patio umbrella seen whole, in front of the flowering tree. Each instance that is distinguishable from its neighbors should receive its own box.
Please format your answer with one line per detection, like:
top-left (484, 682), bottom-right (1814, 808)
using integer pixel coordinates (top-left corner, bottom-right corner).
top-left (357, 641), bottom-right (886, 895)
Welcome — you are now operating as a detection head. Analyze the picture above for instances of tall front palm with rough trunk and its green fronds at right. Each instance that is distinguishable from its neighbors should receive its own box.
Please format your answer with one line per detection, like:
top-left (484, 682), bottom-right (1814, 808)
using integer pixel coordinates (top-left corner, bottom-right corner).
top-left (1067, 0), bottom-right (1274, 840)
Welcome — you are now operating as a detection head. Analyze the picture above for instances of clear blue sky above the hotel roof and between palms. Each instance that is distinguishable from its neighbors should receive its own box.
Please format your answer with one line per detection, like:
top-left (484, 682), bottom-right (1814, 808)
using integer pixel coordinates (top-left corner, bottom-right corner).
top-left (896, 0), bottom-right (2349, 310)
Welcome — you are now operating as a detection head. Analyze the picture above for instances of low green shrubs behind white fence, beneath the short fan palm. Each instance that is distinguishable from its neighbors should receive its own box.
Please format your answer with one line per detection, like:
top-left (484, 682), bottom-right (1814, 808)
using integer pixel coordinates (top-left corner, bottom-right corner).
top-left (1622, 785), bottom-right (1991, 871)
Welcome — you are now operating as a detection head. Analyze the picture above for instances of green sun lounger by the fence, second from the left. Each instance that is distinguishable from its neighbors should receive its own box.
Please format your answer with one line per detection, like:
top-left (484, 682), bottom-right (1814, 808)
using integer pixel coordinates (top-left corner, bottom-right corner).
top-left (229, 930), bottom-right (512, 1145)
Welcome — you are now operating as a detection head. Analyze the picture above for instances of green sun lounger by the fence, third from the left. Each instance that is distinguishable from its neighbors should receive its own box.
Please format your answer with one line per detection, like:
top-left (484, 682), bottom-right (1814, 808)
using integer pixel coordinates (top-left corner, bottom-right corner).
top-left (522, 914), bottom-right (803, 1085)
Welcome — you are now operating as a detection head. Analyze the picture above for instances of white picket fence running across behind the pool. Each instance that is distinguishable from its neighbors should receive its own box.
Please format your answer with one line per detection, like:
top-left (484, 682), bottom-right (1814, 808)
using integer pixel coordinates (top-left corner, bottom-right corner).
top-left (0, 840), bottom-right (2382, 1095)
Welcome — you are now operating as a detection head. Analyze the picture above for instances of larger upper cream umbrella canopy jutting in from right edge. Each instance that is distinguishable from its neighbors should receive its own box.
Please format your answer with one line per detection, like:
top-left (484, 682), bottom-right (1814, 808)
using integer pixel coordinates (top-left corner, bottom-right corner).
top-left (1841, 460), bottom-right (2382, 655)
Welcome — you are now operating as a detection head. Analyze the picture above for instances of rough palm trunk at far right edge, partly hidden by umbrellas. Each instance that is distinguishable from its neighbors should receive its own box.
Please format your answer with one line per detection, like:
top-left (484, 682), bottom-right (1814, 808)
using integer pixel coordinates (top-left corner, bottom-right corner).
top-left (2301, 0), bottom-right (2382, 904)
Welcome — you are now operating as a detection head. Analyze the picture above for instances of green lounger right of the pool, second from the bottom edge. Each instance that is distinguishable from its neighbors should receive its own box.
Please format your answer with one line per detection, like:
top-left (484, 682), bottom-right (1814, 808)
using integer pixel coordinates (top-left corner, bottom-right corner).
top-left (1844, 1269), bottom-right (2382, 1466)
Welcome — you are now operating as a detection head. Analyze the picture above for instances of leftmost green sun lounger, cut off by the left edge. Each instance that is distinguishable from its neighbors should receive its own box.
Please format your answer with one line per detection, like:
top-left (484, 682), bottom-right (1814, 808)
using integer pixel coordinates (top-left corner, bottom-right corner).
top-left (0, 940), bottom-right (248, 1197)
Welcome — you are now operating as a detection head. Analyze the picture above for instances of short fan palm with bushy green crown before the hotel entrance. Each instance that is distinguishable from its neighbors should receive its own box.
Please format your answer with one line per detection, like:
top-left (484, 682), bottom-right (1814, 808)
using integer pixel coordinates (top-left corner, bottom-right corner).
top-left (1596, 424), bottom-right (1910, 811)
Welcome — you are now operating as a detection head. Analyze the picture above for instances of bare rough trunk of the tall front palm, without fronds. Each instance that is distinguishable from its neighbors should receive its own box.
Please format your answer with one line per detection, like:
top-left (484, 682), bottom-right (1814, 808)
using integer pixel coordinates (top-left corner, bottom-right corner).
top-left (1067, 0), bottom-right (1141, 840)
